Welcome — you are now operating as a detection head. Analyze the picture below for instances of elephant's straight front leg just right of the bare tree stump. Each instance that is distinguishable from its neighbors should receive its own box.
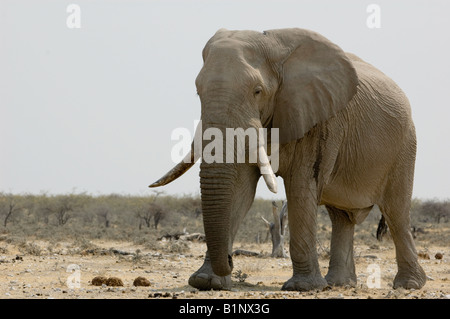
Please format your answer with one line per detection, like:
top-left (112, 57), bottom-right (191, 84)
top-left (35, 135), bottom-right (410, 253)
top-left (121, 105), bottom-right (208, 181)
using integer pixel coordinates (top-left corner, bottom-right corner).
top-left (282, 191), bottom-right (327, 291)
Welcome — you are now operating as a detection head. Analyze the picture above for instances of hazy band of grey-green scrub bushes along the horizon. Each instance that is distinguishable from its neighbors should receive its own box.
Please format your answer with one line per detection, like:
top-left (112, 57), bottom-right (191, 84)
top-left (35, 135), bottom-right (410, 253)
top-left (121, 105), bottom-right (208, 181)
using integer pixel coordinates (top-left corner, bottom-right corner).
top-left (0, 193), bottom-right (450, 248)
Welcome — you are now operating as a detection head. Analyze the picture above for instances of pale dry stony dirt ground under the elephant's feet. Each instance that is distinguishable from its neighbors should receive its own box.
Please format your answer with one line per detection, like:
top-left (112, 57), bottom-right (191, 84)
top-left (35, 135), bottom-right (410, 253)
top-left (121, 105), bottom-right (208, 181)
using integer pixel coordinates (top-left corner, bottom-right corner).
top-left (0, 241), bottom-right (450, 299)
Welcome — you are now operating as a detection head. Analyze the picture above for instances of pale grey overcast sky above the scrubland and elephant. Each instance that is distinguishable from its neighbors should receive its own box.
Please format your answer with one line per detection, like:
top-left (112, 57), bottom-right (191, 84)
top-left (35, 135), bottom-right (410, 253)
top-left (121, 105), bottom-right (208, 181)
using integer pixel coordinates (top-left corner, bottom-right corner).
top-left (0, 0), bottom-right (450, 199)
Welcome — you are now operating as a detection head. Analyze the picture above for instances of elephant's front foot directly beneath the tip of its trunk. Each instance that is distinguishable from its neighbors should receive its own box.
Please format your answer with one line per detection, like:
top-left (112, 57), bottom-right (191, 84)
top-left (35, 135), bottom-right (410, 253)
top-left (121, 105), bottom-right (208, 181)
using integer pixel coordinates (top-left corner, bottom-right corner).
top-left (189, 261), bottom-right (231, 290)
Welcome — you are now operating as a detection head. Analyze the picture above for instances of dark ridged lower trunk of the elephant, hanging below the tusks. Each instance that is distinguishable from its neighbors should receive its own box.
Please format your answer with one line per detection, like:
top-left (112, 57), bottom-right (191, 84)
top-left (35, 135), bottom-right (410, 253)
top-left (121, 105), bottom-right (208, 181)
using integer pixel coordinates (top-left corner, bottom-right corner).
top-left (200, 163), bottom-right (237, 276)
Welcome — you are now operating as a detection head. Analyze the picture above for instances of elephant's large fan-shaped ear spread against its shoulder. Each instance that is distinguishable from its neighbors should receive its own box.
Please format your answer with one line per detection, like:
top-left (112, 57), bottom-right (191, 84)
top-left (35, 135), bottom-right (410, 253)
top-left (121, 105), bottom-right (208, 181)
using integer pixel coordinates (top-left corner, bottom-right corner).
top-left (265, 29), bottom-right (358, 144)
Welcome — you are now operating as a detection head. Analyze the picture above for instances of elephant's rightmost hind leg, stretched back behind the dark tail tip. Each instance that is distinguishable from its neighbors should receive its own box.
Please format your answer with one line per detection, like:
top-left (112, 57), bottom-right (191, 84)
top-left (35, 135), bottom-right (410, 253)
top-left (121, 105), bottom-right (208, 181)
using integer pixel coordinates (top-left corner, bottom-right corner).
top-left (379, 155), bottom-right (426, 289)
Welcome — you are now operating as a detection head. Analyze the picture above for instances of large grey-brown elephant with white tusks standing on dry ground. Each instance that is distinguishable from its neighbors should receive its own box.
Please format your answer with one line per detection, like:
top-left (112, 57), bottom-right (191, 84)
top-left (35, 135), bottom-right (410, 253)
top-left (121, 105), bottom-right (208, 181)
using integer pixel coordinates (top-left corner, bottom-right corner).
top-left (149, 28), bottom-right (426, 291)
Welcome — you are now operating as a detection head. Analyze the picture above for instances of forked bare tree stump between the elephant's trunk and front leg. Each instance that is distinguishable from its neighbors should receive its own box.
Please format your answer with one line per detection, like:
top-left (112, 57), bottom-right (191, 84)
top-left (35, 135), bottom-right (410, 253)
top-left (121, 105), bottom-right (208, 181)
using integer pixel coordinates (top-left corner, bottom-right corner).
top-left (261, 201), bottom-right (288, 258)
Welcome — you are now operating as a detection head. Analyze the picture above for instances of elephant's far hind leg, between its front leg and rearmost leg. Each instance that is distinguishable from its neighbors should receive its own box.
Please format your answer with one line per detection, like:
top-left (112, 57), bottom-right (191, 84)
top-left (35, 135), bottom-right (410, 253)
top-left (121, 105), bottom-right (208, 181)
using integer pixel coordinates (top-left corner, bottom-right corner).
top-left (325, 206), bottom-right (356, 286)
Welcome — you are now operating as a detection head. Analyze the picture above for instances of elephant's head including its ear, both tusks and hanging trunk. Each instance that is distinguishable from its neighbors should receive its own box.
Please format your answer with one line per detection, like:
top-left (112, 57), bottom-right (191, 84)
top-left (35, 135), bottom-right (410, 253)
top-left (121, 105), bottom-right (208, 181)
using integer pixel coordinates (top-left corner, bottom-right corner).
top-left (150, 29), bottom-right (358, 276)
